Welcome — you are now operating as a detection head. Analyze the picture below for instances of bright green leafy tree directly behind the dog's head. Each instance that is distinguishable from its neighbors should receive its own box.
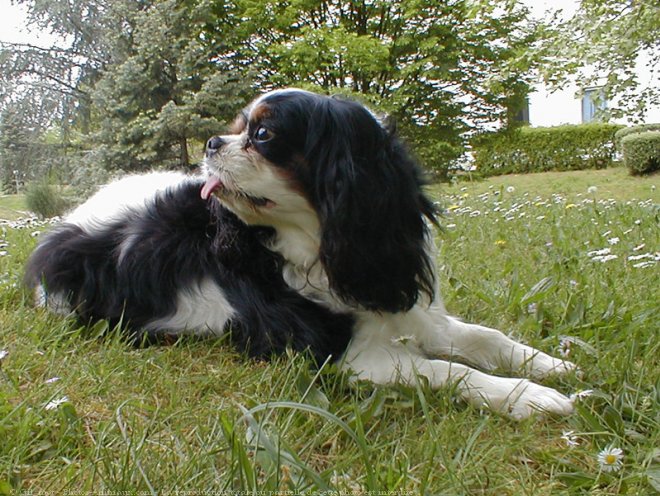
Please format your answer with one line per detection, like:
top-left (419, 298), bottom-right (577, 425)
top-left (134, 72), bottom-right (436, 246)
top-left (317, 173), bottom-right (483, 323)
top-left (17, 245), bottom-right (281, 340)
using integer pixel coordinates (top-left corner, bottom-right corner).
top-left (224, 0), bottom-right (533, 176)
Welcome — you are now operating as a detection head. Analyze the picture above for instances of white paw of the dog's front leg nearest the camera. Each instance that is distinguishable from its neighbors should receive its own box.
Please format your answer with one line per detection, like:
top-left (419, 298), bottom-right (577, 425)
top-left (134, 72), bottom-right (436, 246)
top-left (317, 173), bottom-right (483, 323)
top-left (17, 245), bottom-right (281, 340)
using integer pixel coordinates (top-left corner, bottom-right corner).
top-left (482, 378), bottom-right (573, 420)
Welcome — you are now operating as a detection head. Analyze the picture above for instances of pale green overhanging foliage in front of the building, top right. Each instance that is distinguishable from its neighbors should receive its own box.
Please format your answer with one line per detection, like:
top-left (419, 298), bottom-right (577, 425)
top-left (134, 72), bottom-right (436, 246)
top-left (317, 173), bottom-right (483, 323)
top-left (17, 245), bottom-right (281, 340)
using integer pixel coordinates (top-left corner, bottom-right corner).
top-left (538, 0), bottom-right (660, 120)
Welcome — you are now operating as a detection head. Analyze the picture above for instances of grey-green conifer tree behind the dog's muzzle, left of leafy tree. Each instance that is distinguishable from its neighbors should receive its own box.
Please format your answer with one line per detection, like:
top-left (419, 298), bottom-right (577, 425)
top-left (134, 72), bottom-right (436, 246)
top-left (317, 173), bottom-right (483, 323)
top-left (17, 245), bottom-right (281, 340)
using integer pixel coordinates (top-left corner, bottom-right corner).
top-left (92, 0), bottom-right (252, 170)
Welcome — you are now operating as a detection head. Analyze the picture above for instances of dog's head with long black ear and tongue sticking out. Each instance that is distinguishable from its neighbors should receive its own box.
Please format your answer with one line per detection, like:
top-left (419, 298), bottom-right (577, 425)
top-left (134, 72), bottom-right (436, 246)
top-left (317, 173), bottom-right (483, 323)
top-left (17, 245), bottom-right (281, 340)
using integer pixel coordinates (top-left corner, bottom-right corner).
top-left (202, 89), bottom-right (435, 312)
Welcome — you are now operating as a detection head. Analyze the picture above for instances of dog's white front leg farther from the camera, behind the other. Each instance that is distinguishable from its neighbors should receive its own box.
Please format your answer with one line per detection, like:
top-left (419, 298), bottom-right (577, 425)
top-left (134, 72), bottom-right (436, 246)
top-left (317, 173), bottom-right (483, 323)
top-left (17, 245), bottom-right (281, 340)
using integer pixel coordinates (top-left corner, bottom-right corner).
top-left (418, 315), bottom-right (575, 378)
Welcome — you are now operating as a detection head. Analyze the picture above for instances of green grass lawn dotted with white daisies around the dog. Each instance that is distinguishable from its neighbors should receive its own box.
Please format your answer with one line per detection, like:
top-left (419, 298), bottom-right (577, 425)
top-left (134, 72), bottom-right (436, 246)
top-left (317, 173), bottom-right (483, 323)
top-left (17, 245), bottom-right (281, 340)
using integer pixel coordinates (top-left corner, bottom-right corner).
top-left (0, 170), bottom-right (660, 495)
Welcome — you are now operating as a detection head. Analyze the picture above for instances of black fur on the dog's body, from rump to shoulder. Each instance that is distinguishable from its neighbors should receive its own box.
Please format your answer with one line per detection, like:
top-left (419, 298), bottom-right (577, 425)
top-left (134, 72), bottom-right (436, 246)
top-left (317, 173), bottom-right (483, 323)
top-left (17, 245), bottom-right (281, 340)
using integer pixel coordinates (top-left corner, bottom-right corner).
top-left (26, 181), bottom-right (353, 362)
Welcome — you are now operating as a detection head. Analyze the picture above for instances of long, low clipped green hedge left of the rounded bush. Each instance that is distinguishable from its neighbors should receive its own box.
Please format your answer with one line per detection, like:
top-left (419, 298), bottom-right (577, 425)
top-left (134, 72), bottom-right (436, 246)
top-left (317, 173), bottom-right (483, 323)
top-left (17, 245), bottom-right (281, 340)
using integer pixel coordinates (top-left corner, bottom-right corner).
top-left (472, 123), bottom-right (622, 176)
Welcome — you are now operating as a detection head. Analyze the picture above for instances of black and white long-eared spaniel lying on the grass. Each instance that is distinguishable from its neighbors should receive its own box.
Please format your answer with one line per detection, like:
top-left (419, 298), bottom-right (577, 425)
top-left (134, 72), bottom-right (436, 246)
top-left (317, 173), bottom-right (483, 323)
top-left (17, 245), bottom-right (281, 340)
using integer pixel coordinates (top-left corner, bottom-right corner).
top-left (26, 89), bottom-right (575, 420)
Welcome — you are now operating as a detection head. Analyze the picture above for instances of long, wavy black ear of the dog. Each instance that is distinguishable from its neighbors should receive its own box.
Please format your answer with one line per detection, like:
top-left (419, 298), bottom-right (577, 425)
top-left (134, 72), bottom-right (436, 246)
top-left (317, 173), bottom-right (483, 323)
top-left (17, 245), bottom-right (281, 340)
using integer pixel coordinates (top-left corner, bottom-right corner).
top-left (306, 98), bottom-right (435, 312)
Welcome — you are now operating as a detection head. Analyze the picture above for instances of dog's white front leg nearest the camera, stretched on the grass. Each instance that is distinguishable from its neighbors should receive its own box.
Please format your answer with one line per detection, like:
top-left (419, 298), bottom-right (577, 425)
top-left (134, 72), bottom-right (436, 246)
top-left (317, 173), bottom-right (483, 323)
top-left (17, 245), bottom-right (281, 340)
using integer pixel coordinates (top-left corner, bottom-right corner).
top-left (344, 347), bottom-right (573, 420)
